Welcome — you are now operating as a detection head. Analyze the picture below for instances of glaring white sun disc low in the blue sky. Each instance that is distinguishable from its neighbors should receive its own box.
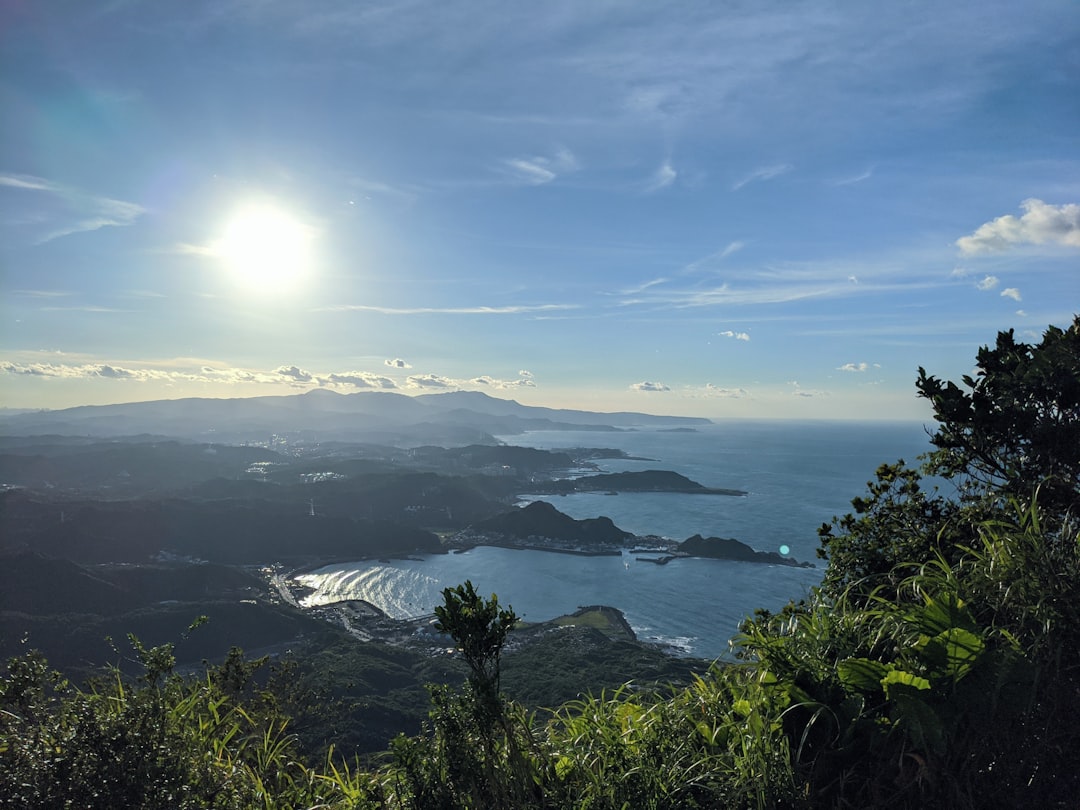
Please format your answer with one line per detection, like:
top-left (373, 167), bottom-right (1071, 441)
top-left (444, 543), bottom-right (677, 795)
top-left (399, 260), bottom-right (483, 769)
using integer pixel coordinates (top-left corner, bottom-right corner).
top-left (217, 203), bottom-right (314, 293)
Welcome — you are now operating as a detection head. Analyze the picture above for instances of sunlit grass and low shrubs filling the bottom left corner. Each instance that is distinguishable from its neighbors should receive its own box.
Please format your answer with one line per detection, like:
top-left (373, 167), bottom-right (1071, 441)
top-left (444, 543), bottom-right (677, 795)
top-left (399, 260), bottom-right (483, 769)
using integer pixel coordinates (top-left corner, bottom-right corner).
top-left (0, 638), bottom-right (379, 810)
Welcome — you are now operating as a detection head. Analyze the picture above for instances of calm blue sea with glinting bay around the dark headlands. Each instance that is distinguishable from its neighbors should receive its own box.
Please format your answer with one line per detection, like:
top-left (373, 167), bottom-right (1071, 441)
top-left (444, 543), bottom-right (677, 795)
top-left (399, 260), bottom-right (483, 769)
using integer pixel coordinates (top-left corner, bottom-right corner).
top-left (301, 421), bottom-right (930, 658)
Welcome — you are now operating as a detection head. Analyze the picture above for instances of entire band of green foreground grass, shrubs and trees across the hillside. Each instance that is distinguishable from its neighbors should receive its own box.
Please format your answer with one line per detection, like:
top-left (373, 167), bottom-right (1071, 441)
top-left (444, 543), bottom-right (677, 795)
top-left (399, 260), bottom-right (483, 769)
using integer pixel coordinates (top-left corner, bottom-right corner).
top-left (0, 319), bottom-right (1080, 810)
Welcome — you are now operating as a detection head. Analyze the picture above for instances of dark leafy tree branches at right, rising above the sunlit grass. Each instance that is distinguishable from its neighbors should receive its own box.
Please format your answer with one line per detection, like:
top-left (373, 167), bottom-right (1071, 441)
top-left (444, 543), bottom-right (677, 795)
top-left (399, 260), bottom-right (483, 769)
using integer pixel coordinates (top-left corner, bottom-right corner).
top-left (819, 318), bottom-right (1080, 597)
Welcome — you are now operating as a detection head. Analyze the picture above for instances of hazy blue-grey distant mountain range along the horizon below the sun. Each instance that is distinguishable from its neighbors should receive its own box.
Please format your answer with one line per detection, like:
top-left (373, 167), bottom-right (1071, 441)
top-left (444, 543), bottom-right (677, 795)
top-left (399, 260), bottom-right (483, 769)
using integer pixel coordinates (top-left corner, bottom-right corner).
top-left (0, 389), bottom-right (710, 446)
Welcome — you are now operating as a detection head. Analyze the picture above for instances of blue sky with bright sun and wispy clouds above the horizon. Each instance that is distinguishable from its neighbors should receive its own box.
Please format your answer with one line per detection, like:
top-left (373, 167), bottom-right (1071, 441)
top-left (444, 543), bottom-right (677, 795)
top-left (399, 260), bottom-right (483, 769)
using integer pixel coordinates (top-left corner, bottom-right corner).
top-left (0, 0), bottom-right (1080, 419)
